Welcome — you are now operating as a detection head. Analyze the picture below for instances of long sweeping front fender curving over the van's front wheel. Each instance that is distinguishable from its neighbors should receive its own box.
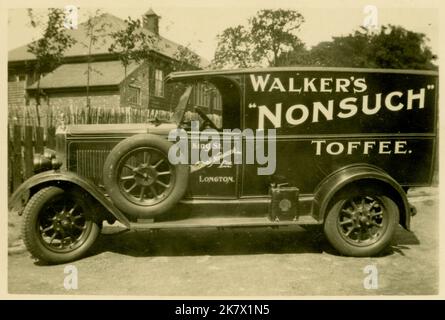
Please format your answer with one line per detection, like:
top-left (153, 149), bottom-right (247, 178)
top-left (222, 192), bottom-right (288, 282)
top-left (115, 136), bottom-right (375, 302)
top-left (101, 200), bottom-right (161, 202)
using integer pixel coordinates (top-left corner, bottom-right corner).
top-left (8, 170), bottom-right (130, 227)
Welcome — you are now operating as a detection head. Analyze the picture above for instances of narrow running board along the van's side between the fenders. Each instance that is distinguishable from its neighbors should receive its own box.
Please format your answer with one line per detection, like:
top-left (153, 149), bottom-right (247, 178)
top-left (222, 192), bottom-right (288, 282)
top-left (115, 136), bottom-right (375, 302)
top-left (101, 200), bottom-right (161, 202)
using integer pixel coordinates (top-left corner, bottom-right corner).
top-left (130, 216), bottom-right (320, 229)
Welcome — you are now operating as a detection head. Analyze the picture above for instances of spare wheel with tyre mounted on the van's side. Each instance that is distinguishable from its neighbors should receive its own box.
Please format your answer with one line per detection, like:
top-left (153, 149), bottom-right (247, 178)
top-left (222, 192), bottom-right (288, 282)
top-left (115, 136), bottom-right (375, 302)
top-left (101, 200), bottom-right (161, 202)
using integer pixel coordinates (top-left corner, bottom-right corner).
top-left (103, 134), bottom-right (189, 218)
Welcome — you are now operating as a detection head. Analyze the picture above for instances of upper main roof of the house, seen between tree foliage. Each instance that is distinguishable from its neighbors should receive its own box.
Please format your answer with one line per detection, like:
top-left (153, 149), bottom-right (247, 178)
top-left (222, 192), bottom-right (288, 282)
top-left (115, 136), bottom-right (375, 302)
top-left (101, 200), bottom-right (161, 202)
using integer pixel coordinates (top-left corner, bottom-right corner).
top-left (8, 12), bottom-right (209, 67)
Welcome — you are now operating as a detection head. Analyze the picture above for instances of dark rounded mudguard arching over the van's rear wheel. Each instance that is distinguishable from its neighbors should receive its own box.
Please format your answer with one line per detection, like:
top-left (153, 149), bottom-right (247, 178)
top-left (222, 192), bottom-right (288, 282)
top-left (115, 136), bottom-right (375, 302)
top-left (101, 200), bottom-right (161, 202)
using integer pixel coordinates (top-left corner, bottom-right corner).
top-left (312, 164), bottom-right (411, 230)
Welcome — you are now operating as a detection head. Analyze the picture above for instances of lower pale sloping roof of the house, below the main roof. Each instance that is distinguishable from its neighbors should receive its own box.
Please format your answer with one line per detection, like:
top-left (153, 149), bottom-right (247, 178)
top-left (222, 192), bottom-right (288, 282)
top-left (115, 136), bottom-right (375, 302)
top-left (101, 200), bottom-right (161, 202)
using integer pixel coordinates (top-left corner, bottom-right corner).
top-left (28, 61), bottom-right (138, 89)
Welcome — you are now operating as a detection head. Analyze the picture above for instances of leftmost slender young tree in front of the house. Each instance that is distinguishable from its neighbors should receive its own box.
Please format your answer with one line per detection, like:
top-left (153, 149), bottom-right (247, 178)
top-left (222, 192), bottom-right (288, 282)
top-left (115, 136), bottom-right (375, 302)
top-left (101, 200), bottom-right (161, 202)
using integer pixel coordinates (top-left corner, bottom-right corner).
top-left (28, 8), bottom-right (75, 126)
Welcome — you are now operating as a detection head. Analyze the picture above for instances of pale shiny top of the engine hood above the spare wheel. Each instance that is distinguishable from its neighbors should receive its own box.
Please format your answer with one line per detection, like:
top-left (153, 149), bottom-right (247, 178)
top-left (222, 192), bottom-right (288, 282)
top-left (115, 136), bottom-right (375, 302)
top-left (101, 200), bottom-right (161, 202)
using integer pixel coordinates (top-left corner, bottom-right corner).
top-left (63, 123), bottom-right (177, 137)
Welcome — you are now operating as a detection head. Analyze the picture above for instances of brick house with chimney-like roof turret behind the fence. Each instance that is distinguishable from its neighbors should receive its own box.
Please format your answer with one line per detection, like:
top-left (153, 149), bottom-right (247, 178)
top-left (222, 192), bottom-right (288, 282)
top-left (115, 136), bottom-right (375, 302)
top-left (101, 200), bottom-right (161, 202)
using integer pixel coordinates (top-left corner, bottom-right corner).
top-left (8, 9), bottom-right (220, 111)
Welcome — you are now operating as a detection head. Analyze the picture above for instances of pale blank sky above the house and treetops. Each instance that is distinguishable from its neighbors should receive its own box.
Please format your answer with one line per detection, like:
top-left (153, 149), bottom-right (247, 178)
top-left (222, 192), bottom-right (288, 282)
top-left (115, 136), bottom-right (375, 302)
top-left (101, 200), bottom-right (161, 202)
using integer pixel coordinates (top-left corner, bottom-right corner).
top-left (7, 0), bottom-right (439, 60)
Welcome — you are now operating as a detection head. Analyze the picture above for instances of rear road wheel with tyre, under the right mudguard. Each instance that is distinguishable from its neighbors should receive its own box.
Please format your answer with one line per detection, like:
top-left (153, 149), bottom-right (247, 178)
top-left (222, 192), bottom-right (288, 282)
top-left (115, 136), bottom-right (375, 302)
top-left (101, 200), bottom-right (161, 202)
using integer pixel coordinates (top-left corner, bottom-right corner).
top-left (324, 190), bottom-right (399, 257)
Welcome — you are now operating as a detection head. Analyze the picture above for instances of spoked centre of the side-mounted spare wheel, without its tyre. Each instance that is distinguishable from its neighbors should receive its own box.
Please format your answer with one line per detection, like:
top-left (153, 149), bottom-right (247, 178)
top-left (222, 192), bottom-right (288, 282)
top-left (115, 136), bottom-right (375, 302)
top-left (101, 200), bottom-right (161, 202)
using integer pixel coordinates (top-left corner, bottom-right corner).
top-left (118, 147), bottom-right (175, 205)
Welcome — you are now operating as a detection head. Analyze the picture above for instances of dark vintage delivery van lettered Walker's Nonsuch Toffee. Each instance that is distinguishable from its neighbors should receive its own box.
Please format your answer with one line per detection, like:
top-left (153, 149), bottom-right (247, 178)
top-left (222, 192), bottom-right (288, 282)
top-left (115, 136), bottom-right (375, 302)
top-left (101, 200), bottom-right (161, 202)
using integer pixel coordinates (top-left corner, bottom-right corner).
top-left (10, 68), bottom-right (438, 263)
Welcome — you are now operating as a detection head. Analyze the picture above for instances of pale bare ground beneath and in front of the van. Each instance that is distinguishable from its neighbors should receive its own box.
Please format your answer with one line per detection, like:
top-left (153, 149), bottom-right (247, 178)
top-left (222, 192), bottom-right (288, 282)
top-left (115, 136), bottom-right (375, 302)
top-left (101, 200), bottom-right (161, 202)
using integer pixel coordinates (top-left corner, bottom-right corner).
top-left (8, 188), bottom-right (439, 297)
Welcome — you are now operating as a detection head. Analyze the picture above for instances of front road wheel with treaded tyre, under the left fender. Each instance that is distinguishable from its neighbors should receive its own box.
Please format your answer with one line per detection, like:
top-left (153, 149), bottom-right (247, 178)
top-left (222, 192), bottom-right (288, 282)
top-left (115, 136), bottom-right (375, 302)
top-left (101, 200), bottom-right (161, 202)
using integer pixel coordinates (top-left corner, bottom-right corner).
top-left (22, 186), bottom-right (100, 264)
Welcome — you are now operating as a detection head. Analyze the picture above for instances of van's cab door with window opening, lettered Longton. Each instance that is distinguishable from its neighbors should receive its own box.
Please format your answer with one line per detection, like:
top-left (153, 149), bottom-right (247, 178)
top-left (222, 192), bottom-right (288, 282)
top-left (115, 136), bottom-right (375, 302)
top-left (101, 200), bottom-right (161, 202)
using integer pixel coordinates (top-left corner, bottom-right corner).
top-left (185, 79), bottom-right (241, 199)
